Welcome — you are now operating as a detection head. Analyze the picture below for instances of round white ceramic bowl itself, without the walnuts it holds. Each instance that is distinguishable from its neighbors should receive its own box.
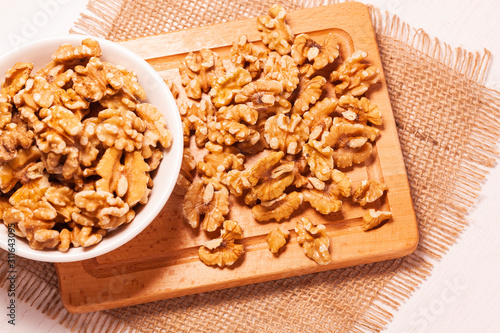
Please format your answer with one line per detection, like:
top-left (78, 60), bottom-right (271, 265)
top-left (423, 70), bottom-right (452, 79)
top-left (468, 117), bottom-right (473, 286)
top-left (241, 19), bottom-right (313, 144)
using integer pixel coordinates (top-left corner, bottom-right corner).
top-left (0, 35), bottom-right (183, 262)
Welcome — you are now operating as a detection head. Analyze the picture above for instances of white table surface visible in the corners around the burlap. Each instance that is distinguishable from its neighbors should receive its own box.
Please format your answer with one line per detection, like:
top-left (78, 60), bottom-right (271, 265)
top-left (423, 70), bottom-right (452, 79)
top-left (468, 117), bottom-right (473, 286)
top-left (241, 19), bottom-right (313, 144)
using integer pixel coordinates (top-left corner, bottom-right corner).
top-left (0, 0), bottom-right (500, 333)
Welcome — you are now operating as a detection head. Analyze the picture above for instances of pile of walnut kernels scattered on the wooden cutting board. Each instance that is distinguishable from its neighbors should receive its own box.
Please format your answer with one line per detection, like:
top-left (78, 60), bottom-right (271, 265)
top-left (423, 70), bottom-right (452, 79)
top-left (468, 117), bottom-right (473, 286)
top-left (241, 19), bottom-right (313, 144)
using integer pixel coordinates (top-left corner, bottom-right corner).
top-left (170, 5), bottom-right (387, 267)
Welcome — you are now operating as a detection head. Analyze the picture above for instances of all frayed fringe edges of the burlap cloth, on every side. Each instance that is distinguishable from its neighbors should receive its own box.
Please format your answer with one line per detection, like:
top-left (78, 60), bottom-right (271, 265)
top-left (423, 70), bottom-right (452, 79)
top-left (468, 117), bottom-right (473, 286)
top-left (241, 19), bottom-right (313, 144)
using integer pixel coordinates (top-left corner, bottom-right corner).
top-left (0, 0), bottom-right (500, 332)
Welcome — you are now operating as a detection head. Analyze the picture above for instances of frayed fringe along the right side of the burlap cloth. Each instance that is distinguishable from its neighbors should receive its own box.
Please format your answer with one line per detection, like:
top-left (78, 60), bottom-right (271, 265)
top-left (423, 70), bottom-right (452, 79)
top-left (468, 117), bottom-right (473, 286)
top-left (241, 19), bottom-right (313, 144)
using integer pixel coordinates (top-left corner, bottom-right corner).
top-left (353, 6), bottom-right (500, 332)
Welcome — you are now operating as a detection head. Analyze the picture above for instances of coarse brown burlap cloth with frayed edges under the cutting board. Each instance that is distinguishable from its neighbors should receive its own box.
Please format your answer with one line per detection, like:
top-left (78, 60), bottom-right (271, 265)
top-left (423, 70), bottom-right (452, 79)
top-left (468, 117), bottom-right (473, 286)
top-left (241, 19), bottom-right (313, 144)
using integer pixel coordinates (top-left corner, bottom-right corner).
top-left (0, 0), bottom-right (500, 332)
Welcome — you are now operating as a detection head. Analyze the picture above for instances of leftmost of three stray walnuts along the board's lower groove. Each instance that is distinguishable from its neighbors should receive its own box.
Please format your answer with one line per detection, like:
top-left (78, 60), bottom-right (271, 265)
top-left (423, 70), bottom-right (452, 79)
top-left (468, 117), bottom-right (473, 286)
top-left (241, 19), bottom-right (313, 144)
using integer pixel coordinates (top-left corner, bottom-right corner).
top-left (198, 220), bottom-right (245, 267)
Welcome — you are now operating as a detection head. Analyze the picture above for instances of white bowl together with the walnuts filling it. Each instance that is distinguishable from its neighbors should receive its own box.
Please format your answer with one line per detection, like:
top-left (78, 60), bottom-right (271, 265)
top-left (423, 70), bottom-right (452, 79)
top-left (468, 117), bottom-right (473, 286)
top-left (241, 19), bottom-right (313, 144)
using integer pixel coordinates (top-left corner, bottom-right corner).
top-left (0, 36), bottom-right (183, 262)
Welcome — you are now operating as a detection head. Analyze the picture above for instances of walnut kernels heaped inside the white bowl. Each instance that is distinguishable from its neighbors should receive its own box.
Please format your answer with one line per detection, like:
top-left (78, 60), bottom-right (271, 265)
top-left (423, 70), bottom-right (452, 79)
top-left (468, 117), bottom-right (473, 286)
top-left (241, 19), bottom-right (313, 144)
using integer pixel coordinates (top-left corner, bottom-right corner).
top-left (0, 39), bottom-right (172, 252)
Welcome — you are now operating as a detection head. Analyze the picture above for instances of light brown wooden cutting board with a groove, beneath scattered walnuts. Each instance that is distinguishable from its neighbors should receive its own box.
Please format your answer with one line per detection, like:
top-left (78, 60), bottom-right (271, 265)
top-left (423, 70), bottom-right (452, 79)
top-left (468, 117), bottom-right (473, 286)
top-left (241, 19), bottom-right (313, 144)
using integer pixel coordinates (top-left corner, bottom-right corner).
top-left (56, 3), bottom-right (418, 313)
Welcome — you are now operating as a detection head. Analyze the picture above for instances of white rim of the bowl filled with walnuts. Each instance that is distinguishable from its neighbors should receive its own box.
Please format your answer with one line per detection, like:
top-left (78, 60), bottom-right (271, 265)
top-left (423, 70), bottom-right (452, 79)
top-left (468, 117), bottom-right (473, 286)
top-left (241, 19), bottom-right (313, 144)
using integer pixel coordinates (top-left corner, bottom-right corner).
top-left (0, 34), bottom-right (184, 263)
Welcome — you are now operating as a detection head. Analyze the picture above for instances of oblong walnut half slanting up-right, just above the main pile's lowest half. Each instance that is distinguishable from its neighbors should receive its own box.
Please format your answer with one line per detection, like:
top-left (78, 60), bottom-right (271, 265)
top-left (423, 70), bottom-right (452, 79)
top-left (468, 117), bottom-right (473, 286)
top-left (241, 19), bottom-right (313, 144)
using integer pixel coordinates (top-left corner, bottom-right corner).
top-left (245, 161), bottom-right (295, 206)
